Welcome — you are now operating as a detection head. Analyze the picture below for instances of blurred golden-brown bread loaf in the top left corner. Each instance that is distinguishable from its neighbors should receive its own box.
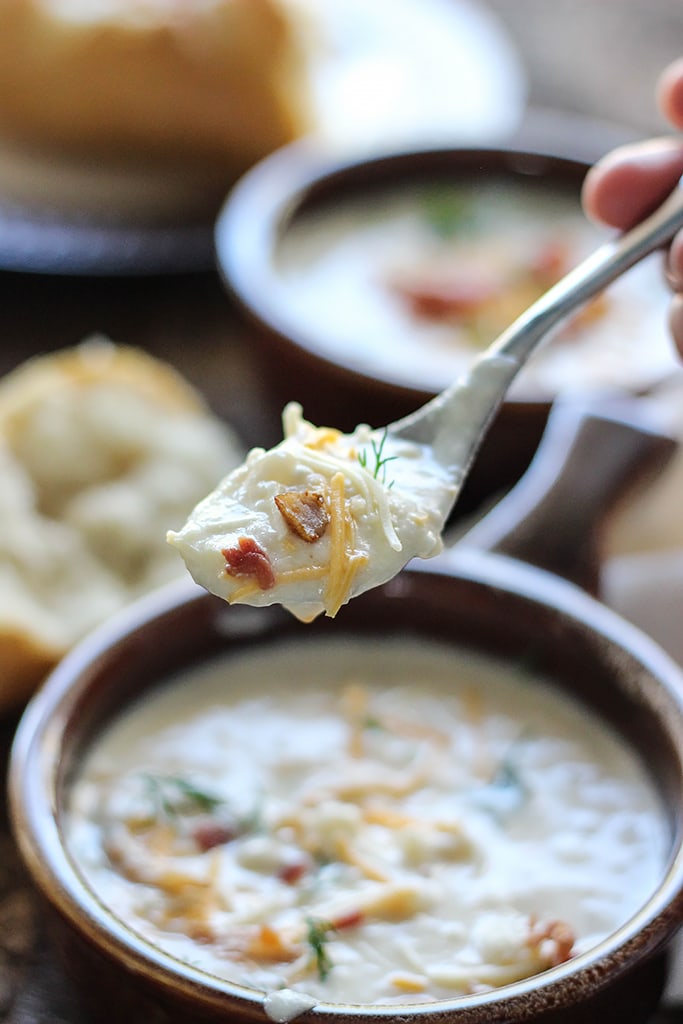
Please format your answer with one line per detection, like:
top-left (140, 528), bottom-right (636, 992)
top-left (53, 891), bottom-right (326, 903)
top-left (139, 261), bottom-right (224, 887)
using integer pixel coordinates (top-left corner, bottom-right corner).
top-left (0, 0), bottom-right (308, 172)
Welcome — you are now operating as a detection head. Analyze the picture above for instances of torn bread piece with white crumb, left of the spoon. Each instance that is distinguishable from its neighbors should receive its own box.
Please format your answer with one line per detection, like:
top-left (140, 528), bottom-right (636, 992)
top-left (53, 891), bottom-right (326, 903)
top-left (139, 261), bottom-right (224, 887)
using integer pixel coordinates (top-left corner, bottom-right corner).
top-left (0, 339), bottom-right (244, 710)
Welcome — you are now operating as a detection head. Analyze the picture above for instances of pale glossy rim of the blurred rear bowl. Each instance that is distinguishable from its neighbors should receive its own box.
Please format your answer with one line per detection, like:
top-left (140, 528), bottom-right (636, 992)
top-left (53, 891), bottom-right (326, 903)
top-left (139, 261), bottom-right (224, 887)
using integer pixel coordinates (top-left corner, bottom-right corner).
top-left (214, 138), bottom-right (602, 410)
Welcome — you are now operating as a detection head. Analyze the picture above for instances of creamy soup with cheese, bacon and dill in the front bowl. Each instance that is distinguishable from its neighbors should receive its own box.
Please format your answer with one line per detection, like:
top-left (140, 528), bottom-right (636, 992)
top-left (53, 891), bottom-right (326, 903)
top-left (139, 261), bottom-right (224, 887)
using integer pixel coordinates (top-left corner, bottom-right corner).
top-left (66, 638), bottom-right (667, 1020)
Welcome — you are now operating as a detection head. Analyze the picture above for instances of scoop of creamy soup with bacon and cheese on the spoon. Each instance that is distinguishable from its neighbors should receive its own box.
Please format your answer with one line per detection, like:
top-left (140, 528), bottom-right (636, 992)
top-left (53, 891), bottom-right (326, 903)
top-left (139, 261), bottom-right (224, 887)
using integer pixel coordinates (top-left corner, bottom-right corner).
top-left (167, 403), bottom-right (458, 622)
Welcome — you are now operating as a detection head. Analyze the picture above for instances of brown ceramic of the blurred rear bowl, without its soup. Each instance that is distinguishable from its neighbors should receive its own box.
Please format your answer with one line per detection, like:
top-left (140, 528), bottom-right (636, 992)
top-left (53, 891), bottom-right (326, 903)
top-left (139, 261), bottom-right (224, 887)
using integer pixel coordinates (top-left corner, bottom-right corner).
top-left (216, 142), bottom-right (675, 511)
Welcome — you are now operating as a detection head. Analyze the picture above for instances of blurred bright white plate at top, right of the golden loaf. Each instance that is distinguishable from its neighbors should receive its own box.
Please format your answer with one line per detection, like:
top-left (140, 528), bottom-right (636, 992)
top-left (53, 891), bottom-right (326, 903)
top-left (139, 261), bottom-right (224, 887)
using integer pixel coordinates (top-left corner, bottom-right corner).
top-left (294, 0), bottom-right (526, 155)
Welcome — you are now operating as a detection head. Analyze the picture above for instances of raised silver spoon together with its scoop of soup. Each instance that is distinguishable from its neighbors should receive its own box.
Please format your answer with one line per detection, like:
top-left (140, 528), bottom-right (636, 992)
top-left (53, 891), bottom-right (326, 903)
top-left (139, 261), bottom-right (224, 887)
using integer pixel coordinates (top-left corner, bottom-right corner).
top-left (168, 173), bottom-right (683, 622)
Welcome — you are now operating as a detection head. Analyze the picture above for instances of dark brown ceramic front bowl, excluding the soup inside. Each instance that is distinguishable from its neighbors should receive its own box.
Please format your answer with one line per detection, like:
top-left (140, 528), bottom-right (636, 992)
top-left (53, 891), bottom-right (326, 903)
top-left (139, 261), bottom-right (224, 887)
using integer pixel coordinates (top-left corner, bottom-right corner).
top-left (10, 403), bottom-right (683, 1024)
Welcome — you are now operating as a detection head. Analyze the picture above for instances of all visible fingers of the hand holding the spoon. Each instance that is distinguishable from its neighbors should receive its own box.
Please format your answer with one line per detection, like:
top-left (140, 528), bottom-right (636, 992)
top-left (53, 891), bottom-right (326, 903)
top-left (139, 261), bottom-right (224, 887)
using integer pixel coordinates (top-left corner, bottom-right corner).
top-left (582, 57), bottom-right (683, 355)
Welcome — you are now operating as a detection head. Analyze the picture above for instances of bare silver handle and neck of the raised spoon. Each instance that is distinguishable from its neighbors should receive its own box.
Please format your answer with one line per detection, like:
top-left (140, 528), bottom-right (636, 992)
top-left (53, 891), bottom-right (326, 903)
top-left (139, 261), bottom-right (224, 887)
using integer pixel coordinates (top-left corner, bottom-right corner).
top-left (387, 178), bottom-right (683, 504)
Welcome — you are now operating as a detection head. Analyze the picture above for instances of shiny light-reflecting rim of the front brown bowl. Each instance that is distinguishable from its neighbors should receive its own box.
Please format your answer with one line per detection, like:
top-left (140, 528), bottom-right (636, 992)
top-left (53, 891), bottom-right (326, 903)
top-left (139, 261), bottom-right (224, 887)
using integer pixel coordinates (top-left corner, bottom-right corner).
top-left (8, 565), bottom-right (683, 1024)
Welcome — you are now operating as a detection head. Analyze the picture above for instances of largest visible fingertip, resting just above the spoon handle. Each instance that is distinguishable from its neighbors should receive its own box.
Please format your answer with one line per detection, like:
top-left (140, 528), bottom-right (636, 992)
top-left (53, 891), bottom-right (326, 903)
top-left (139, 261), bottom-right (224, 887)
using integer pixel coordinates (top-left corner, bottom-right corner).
top-left (582, 138), bottom-right (683, 229)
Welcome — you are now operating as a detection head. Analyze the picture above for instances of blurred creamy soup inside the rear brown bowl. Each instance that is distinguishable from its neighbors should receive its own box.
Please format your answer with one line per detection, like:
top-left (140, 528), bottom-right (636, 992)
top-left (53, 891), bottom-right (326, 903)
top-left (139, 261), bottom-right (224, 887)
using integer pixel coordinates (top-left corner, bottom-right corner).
top-left (271, 178), bottom-right (676, 399)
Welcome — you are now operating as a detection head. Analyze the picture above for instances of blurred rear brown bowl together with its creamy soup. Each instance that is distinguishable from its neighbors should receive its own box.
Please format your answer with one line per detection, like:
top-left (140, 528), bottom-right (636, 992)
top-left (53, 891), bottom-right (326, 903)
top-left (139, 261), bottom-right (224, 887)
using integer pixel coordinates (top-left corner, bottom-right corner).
top-left (216, 142), bottom-right (674, 511)
